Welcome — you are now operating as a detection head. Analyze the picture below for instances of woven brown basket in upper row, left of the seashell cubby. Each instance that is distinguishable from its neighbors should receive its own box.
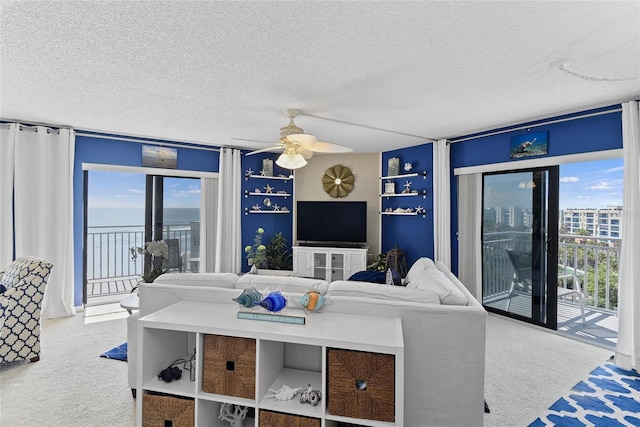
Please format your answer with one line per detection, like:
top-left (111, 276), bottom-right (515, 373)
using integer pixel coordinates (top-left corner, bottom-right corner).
top-left (202, 335), bottom-right (256, 399)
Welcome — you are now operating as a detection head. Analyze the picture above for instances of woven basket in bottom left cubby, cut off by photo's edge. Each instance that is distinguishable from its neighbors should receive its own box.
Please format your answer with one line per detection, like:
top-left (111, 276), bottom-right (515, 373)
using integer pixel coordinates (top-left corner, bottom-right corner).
top-left (142, 393), bottom-right (195, 427)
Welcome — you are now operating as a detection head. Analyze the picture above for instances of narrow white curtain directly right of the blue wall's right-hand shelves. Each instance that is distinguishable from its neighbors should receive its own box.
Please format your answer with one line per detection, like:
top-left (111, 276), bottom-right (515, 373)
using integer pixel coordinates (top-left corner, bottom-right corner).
top-left (433, 139), bottom-right (452, 268)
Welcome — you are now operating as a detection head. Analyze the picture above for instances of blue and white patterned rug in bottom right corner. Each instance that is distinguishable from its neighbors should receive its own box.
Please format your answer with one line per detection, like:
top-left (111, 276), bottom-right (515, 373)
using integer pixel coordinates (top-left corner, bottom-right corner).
top-left (529, 363), bottom-right (640, 427)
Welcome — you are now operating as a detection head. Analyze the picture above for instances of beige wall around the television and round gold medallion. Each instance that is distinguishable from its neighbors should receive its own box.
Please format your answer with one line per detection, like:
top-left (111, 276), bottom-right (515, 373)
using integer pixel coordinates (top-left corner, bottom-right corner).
top-left (293, 153), bottom-right (380, 254)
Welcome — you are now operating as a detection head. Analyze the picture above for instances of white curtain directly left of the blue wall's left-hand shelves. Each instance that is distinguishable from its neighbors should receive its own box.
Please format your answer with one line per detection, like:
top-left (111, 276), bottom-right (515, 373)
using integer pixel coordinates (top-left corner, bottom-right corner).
top-left (215, 148), bottom-right (243, 273)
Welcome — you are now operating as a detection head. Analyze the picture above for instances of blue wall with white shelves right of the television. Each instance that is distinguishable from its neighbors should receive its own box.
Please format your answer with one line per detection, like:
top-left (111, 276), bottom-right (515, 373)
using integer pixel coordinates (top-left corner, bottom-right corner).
top-left (380, 144), bottom-right (433, 267)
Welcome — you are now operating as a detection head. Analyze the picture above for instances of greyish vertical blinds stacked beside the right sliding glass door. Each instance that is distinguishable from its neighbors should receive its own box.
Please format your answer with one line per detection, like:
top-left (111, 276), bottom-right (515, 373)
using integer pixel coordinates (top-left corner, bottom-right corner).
top-left (458, 173), bottom-right (482, 301)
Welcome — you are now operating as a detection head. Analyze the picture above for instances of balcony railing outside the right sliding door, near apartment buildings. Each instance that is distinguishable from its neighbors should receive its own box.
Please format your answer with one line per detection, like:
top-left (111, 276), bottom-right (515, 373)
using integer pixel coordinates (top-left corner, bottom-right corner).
top-left (483, 232), bottom-right (620, 311)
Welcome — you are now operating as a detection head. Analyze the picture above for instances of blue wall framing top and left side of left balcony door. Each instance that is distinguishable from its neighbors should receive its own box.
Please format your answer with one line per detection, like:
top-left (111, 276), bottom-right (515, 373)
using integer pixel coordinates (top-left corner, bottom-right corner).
top-left (73, 135), bottom-right (220, 306)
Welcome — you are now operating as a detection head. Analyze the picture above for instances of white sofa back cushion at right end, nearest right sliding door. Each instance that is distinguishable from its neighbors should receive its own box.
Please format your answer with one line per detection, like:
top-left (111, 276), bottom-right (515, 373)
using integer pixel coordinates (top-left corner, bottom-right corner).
top-left (405, 258), bottom-right (468, 305)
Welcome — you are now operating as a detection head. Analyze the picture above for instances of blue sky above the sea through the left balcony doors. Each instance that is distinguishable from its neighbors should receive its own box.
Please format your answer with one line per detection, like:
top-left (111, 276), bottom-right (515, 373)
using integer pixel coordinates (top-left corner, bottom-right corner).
top-left (89, 171), bottom-right (200, 208)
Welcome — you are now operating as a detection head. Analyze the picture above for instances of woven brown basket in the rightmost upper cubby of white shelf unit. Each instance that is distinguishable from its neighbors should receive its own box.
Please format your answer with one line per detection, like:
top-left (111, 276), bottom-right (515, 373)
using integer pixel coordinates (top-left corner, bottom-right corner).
top-left (327, 349), bottom-right (395, 422)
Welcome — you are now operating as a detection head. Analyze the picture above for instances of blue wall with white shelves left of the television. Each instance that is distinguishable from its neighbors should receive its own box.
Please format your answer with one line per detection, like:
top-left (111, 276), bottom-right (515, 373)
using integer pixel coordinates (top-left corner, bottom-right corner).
top-left (241, 153), bottom-right (295, 272)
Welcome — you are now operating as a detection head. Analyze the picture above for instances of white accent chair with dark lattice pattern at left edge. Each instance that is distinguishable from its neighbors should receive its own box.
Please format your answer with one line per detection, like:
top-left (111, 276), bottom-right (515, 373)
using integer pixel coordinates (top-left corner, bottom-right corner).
top-left (0, 257), bottom-right (53, 363)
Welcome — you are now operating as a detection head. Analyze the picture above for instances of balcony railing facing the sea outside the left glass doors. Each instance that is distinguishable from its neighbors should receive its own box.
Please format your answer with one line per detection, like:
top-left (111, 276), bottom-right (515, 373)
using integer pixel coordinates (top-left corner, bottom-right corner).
top-left (86, 223), bottom-right (200, 296)
